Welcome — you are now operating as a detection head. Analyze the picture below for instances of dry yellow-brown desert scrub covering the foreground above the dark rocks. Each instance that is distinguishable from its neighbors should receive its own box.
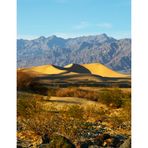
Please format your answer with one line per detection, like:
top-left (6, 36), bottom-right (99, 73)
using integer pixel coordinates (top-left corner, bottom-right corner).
top-left (17, 87), bottom-right (130, 147)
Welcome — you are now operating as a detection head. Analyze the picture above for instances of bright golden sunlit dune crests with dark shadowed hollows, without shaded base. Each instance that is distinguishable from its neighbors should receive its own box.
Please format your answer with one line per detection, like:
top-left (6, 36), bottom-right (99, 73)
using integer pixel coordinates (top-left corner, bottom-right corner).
top-left (17, 63), bottom-right (128, 78)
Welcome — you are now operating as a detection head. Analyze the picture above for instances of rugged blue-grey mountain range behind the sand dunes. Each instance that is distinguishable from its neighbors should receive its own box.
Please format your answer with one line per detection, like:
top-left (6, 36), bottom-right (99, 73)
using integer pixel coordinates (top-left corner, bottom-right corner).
top-left (17, 34), bottom-right (131, 73)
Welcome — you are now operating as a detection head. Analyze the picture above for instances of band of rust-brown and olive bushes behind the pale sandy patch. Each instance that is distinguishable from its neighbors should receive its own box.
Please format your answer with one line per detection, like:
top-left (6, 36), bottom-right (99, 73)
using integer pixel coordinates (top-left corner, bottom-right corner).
top-left (55, 88), bottom-right (131, 108)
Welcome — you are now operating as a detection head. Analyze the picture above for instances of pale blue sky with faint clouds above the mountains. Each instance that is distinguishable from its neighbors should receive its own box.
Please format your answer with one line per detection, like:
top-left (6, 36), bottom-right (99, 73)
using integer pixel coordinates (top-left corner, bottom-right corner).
top-left (17, 0), bottom-right (131, 39)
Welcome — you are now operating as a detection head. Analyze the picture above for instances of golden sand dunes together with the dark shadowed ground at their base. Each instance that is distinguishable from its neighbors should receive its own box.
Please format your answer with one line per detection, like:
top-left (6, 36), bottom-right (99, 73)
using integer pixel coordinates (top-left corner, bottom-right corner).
top-left (17, 63), bottom-right (130, 89)
